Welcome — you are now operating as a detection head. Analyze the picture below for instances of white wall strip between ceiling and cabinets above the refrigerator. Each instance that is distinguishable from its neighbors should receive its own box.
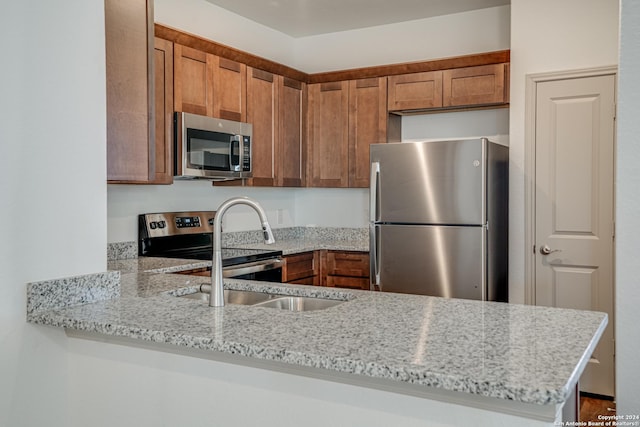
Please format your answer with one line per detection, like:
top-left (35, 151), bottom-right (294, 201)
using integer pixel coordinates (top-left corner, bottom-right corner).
top-left (293, 6), bottom-right (509, 73)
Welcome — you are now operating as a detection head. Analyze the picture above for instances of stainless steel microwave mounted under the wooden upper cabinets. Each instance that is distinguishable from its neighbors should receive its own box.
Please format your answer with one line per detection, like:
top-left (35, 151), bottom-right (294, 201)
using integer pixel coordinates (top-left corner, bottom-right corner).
top-left (173, 112), bottom-right (252, 181)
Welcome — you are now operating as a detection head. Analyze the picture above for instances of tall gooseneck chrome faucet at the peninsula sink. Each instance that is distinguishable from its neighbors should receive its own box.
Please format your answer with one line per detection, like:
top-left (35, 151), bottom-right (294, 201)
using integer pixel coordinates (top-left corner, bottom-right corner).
top-left (209, 197), bottom-right (276, 307)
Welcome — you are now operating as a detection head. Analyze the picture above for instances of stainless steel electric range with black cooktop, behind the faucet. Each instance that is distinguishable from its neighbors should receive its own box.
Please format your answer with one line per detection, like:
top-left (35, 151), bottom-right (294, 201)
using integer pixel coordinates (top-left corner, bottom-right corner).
top-left (138, 211), bottom-right (283, 282)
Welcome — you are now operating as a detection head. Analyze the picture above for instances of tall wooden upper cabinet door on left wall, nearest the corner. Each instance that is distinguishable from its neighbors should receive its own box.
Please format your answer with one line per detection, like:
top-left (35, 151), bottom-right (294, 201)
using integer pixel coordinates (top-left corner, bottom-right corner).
top-left (276, 77), bottom-right (306, 187)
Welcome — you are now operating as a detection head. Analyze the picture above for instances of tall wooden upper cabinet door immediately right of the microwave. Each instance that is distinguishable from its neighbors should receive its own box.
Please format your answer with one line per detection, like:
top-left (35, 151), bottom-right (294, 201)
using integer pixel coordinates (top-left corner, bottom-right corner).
top-left (247, 68), bottom-right (279, 186)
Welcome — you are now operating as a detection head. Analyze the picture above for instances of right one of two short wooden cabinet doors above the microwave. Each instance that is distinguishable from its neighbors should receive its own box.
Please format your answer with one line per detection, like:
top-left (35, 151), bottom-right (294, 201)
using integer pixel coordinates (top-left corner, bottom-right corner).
top-left (213, 56), bottom-right (247, 122)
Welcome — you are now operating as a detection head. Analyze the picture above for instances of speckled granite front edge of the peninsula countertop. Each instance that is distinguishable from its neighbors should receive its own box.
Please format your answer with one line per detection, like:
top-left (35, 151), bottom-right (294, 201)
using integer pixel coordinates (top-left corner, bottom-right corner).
top-left (29, 294), bottom-right (607, 405)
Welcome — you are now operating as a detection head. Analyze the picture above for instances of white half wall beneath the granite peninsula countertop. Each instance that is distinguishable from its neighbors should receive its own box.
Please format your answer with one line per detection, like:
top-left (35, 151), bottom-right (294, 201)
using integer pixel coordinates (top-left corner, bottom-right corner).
top-left (65, 339), bottom-right (552, 427)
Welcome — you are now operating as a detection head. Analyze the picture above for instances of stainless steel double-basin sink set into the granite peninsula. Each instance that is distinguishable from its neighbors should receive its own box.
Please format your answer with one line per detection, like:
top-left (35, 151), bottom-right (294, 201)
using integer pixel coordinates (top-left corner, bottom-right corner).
top-left (180, 285), bottom-right (344, 311)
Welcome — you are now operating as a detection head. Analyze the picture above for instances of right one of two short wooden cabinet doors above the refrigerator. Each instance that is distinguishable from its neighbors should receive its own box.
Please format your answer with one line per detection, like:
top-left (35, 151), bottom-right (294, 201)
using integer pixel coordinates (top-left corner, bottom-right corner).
top-left (442, 64), bottom-right (508, 107)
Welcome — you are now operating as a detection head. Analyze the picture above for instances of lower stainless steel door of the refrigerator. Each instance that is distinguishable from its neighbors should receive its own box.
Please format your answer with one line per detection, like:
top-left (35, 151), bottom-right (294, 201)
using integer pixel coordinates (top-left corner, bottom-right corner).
top-left (370, 224), bottom-right (486, 300)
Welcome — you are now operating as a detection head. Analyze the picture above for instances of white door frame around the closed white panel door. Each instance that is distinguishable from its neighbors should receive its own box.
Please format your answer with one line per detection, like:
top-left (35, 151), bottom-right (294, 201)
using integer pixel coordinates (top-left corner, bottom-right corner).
top-left (524, 65), bottom-right (618, 308)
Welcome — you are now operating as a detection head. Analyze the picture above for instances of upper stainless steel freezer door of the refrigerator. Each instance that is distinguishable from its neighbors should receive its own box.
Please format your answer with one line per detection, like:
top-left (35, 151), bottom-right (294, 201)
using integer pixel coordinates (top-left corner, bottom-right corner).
top-left (370, 138), bottom-right (488, 225)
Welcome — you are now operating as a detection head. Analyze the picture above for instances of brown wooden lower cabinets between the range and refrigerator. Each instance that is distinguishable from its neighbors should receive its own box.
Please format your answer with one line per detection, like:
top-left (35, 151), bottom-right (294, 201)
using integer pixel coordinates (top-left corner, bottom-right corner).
top-left (282, 250), bottom-right (369, 290)
